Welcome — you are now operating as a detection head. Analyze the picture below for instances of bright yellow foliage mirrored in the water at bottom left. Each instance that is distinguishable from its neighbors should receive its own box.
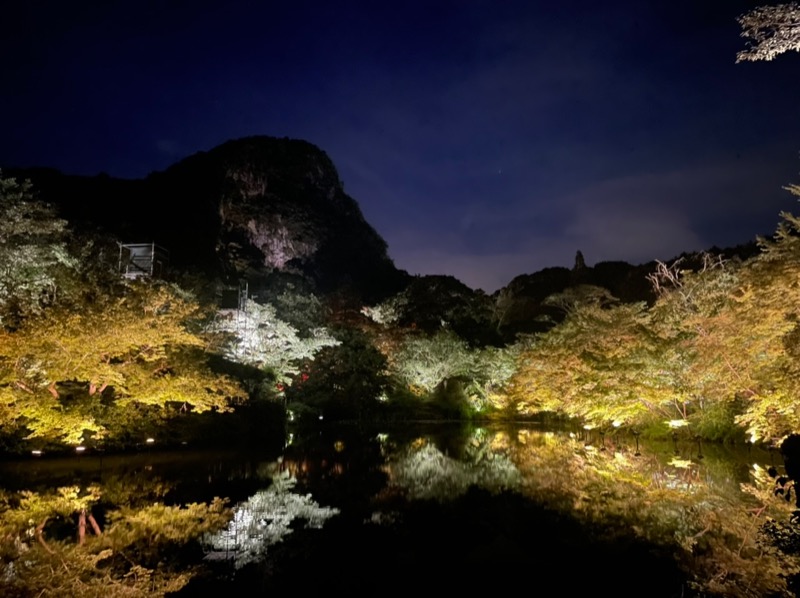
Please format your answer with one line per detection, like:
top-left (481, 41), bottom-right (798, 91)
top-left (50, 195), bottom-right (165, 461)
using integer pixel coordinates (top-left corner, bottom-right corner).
top-left (0, 487), bottom-right (230, 598)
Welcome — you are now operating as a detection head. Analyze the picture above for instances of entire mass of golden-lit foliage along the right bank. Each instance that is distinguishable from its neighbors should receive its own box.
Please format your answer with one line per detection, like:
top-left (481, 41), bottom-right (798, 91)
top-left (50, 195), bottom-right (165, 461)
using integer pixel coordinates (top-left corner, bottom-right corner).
top-left (506, 240), bottom-right (800, 442)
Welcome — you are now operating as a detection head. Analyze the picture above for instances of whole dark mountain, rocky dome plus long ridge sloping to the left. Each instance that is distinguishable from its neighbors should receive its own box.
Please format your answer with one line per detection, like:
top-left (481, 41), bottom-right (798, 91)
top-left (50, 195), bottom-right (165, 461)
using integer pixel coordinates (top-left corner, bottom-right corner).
top-left (12, 136), bottom-right (407, 298)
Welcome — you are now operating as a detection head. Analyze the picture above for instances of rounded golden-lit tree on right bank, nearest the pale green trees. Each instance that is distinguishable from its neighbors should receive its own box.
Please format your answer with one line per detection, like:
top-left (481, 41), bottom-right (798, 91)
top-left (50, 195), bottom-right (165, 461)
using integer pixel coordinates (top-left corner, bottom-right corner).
top-left (511, 303), bottom-right (685, 426)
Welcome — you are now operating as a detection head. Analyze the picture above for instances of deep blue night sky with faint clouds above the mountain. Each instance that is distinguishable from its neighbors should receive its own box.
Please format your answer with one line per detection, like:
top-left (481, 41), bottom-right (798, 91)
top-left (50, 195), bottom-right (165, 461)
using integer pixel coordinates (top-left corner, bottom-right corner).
top-left (0, 0), bottom-right (800, 292)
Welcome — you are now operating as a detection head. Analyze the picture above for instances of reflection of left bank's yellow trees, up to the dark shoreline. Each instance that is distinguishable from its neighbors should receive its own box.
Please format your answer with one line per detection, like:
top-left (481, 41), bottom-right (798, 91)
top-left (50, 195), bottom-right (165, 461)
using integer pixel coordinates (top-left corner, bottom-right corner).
top-left (0, 455), bottom-right (263, 598)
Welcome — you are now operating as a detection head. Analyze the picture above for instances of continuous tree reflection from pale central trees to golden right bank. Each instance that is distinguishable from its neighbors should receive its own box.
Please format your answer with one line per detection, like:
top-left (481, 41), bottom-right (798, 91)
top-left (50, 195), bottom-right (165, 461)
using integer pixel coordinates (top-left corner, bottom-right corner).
top-left (380, 429), bottom-right (800, 596)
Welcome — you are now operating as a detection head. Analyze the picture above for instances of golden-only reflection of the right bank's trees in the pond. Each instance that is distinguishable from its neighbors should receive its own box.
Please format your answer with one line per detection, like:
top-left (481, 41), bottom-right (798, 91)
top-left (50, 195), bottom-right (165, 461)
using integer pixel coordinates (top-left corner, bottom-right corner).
top-left (507, 430), bottom-right (800, 596)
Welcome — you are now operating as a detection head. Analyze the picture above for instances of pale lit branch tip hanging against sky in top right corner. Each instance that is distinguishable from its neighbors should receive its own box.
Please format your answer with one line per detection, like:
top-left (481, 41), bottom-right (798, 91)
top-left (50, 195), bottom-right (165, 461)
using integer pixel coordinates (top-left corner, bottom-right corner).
top-left (736, 2), bottom-right (800, 62)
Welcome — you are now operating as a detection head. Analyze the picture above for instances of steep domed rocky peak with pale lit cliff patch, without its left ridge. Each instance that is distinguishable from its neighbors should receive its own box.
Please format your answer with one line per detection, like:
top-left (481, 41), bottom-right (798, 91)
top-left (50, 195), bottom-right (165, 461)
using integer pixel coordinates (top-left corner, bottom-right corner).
top-left (168, 137), bottom-right (402, 295)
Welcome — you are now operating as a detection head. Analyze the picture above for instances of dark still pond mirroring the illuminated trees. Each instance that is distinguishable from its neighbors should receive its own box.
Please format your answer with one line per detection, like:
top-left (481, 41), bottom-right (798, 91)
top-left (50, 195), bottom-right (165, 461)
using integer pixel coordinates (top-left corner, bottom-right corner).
top-left (0, 424), bottom-right (798, 596)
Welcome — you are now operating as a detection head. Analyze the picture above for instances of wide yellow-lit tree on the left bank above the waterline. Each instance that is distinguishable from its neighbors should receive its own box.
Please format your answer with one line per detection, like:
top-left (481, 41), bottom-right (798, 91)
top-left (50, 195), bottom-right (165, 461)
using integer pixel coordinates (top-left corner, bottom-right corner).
top-left (0, 281), bottom-right (243, 443)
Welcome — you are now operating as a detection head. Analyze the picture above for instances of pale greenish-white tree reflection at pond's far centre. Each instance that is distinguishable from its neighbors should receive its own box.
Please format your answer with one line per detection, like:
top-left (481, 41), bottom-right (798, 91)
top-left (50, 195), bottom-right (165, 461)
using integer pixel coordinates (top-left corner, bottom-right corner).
top-left (388, 444), bottom-right (521, 500)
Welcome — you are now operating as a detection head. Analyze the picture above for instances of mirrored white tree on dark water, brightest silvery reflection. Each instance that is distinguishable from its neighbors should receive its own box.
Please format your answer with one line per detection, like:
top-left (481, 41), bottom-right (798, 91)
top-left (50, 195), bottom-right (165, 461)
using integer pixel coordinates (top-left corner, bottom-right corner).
top-left (206, 473), bottom-right (339, 568)
